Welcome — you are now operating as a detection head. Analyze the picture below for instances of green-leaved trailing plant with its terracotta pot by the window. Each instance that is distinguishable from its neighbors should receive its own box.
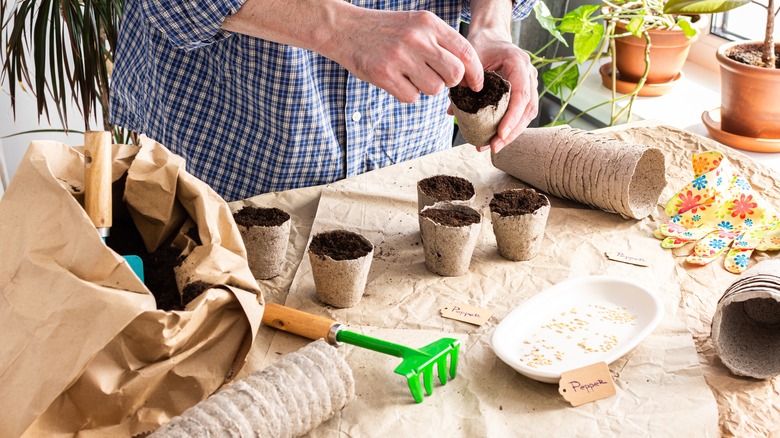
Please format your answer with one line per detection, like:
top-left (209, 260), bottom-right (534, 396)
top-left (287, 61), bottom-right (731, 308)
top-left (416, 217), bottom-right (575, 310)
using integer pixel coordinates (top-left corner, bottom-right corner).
top-left (529, 0), bottom-right (698, 125)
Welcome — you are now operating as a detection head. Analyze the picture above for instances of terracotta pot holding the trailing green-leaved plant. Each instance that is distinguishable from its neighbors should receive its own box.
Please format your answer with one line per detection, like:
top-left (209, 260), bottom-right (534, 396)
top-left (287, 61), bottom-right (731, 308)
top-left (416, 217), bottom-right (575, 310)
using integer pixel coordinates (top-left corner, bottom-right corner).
top-left (615, 21), bottom-right (697, 84)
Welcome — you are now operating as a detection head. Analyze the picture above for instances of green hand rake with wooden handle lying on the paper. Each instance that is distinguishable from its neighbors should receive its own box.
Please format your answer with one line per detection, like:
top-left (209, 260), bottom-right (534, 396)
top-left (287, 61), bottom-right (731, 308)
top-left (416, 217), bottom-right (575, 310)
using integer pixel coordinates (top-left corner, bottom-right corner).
top-left (263, 303), bottom-right (460, 403)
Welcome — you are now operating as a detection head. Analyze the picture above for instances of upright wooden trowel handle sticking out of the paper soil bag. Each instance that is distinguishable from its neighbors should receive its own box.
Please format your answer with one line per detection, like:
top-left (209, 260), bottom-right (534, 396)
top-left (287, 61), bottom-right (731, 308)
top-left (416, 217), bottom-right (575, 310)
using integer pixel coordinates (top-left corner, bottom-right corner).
top-left (84, 131), bottom-right (113, 231)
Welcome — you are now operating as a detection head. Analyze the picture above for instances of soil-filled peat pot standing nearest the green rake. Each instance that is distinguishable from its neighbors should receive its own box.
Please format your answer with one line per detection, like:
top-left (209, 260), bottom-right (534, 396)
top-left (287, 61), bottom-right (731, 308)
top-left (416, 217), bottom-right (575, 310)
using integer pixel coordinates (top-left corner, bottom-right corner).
top-left (309, 230), bottom-right (374, 308)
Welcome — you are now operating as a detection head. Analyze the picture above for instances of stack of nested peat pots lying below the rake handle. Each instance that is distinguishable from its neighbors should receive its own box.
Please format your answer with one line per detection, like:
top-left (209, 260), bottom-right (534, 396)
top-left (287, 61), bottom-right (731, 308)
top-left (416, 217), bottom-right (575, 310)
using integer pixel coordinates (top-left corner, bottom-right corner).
top-left (149, 339), bottom-right (355, 438)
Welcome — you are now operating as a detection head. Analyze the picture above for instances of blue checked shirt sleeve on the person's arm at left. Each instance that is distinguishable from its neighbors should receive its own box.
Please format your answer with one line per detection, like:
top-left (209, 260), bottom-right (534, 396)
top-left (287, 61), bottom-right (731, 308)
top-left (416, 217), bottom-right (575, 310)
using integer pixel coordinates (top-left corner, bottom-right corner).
top-left (138, 0), bottom-right (244, 50)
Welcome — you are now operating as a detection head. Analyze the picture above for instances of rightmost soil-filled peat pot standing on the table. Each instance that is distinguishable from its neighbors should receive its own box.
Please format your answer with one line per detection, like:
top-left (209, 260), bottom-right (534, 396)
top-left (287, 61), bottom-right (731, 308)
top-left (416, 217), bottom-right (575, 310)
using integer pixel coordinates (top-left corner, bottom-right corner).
top-left (490, 189), bottom-right (550, 261)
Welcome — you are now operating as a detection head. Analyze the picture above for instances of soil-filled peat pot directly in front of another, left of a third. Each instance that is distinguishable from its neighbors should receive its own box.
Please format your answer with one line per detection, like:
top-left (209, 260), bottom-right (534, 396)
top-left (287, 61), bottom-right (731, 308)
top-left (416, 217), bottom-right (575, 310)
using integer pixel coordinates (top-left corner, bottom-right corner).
top-left (420, 202), bottom-right (482, 277)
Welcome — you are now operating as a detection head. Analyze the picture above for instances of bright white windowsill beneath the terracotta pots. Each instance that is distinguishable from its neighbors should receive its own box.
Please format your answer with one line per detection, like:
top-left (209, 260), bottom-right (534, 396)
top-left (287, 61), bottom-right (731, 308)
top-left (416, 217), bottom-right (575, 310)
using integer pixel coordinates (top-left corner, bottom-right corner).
top-left (569, 60), bottom-right (780, 173)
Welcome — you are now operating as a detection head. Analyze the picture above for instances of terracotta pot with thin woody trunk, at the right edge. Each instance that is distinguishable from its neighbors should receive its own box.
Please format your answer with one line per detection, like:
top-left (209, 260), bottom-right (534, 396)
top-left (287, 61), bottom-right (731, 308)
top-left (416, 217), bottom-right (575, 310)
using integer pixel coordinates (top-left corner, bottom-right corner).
top-left (716, 41), bottom-right (780, 139)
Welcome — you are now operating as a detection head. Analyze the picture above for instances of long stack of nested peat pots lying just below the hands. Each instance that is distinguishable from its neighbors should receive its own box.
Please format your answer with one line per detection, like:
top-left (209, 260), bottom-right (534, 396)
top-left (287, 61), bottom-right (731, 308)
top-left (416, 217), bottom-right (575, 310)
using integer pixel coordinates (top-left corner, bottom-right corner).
top-left (491, 126), bottom-right (666, 219)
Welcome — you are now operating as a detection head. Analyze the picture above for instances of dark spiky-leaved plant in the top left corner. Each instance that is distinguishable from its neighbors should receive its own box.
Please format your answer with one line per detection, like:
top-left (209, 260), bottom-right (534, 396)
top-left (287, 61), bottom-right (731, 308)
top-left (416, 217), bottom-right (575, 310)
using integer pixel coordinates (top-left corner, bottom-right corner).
top-left (0, 0), bottom-right (134, 143)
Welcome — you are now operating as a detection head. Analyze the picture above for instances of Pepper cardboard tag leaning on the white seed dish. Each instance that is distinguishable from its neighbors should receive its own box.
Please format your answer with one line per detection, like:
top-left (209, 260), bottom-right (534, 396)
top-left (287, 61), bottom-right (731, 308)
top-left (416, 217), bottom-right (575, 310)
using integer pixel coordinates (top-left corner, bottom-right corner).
top-left (558, 362), bottom-right (616, 406)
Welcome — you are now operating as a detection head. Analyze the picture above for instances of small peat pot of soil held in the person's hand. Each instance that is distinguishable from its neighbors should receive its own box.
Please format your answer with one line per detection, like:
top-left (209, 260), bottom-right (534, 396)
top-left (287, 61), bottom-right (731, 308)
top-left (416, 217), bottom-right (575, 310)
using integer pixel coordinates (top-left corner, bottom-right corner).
top-left (450, 70), bottom-right (511, 146)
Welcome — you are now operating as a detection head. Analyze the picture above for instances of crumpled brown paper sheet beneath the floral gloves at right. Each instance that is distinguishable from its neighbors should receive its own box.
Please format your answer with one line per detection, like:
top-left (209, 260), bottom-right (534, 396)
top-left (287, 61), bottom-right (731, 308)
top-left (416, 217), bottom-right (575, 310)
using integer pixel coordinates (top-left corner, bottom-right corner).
top-left (611, 126), bottom-right (780, 437)
